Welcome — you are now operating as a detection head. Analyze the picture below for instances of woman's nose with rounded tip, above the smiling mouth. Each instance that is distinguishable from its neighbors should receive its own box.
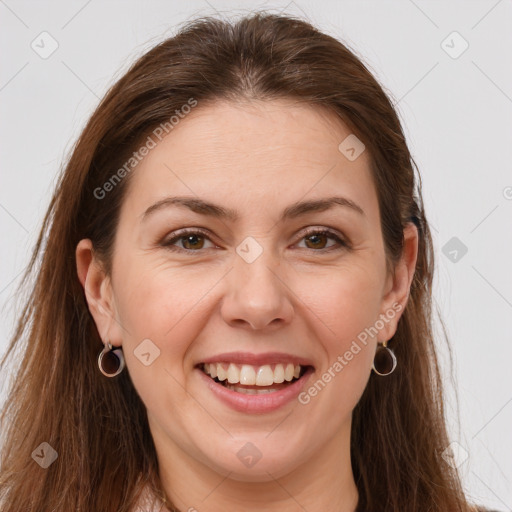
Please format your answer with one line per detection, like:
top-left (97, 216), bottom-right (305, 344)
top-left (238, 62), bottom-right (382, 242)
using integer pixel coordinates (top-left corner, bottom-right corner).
top-left (221, 246), bottom-right (294, 330)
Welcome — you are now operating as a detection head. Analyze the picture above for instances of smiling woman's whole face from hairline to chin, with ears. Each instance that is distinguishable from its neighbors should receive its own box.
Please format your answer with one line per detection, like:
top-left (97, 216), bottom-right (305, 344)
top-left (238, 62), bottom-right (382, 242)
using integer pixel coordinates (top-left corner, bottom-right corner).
top-left (77, 100), bottom-right (415, 480)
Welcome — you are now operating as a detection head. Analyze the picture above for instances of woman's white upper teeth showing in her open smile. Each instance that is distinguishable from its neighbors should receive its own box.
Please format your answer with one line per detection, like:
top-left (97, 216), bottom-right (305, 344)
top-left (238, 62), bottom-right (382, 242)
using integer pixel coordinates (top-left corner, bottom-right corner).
top-left (203, 363), bottom-right (301, 386)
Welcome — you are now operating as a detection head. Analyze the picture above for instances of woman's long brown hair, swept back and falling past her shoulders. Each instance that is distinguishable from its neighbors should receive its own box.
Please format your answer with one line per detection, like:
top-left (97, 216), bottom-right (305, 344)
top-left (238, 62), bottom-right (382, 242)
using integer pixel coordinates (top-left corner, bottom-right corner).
top-left (0, 12), bottom-right (486, 512)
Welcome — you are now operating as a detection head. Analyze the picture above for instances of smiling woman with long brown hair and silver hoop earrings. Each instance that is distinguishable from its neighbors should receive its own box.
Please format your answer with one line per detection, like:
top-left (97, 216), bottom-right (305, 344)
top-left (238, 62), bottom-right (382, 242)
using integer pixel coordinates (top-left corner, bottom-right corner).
top-left (0, 13), bottom-right (498, 512)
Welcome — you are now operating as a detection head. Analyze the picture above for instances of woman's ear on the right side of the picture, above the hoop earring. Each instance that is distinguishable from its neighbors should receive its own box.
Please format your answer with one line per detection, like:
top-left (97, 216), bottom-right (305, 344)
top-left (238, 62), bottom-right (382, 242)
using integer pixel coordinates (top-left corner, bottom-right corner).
top-left (378, 222), bottom-right (419, 341)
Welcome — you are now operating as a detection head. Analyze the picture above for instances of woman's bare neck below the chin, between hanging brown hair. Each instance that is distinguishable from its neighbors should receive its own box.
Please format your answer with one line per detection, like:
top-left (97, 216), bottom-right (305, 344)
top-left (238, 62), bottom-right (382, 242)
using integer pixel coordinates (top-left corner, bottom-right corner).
top-left (155, 421), bottom-right (358, 512)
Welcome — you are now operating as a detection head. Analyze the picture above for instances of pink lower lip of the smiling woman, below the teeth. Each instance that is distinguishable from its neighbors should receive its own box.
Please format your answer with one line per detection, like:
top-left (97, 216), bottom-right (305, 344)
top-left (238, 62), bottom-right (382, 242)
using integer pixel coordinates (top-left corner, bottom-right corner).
top-left (196, 367), bottom-right (314, 413)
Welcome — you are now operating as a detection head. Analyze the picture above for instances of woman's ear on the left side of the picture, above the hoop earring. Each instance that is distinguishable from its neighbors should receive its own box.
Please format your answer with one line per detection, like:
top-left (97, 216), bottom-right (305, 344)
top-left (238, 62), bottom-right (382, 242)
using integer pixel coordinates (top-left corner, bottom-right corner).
top-left (75, 239), bottom-right (122, 346)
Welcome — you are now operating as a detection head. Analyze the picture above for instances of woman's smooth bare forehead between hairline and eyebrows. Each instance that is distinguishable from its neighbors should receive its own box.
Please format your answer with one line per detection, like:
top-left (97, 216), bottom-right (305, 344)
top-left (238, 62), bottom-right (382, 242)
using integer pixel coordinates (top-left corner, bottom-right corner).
top-left (119, 99), bottom-right (376, 221)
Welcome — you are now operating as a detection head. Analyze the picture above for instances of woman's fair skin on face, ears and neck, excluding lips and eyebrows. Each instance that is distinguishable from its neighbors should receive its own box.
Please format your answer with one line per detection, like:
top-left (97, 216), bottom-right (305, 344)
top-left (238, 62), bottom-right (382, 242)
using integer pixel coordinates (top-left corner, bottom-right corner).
top-left (76, 100), bottom-right (418, 512)
